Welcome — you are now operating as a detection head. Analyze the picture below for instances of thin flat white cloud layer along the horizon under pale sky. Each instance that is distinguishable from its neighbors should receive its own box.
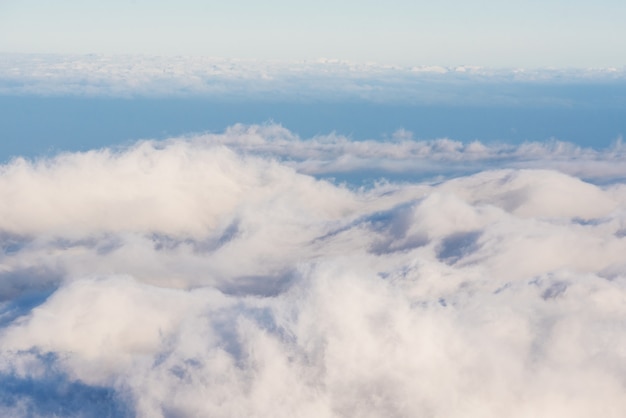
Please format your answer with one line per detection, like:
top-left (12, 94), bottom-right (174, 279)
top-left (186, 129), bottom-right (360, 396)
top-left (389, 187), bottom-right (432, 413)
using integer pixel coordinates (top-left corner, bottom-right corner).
top-left (0, 54), bottom-right (626, 106)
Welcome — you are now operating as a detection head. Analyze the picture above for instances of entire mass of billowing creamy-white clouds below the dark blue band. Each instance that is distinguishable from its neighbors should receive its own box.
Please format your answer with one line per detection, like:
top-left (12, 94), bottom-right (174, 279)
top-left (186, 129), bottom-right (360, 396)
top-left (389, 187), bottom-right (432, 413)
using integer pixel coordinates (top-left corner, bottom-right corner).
top-left (0, 125), bottom-right (626, 417)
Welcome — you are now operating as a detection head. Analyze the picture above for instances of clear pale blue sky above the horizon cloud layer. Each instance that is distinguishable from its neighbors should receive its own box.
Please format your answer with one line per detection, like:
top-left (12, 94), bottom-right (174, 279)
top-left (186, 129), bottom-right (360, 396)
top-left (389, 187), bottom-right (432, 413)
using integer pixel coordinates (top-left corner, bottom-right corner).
top-left (0, 0), bottom-right (626, 67)
